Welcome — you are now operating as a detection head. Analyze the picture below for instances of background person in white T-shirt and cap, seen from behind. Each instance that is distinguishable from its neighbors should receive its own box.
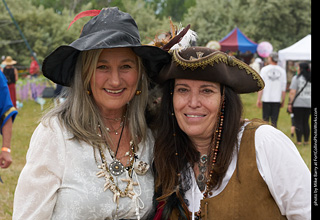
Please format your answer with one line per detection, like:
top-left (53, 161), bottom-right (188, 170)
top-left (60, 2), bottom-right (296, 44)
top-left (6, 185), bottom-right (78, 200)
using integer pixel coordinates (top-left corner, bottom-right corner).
top-left (257, 52), bottom-right (287, 127)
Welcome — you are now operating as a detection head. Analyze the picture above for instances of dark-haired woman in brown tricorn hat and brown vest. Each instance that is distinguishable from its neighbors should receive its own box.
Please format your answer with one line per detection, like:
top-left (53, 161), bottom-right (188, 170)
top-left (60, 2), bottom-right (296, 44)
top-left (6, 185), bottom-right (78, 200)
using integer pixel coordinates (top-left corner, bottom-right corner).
top-left (154, 47), bottom-right (311, 220)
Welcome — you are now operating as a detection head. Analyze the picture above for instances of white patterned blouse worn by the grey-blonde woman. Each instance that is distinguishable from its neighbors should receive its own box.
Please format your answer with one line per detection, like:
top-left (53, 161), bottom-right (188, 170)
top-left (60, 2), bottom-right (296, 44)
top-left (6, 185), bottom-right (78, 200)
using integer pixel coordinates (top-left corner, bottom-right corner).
top-left (13, 118), bottom-right (154, 220)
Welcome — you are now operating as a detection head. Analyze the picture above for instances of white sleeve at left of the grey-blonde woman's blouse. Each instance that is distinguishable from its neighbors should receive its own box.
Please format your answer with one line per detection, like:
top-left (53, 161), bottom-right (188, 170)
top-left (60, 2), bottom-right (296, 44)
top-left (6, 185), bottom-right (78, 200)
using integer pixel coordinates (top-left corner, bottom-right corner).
top-left (13, 120), bottom-right (65, 220)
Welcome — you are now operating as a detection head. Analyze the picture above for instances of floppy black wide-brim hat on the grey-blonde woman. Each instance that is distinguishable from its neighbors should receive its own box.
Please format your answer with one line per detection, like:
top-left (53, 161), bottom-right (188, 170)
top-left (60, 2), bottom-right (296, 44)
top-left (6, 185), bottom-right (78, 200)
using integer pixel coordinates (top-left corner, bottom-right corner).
top-left (42, 7), bottom-right (171, 86)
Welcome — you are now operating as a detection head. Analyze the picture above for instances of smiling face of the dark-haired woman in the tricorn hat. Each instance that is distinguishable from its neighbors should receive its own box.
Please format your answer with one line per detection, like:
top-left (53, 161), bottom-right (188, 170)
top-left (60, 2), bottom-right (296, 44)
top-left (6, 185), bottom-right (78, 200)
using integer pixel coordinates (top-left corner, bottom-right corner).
top-left (173, 79), bottom-right (221, 142)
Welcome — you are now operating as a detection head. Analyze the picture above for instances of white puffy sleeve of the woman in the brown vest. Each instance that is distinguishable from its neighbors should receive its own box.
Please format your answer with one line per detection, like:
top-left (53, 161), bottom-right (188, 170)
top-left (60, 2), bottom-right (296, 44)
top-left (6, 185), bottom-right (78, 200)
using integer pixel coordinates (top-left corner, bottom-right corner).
top-left (255, 125), bottom-right (311, 220)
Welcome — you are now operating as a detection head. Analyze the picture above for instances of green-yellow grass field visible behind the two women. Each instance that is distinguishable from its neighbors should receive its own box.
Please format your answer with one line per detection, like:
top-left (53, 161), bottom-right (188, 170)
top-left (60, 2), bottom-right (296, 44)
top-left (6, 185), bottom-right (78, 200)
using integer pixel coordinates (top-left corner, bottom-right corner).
top-left (0, 94), bottom-right (311, 220)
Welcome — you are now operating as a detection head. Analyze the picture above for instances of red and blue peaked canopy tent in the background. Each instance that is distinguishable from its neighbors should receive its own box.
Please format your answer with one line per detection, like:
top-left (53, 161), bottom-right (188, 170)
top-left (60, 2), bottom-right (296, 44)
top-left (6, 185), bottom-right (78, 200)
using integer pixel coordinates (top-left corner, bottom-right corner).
top-left (219, 27), bottom-right (258, 53)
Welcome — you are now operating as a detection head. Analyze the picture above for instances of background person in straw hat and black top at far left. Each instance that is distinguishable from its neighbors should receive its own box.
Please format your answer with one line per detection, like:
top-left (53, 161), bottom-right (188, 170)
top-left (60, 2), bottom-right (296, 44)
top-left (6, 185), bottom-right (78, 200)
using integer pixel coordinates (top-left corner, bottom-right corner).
top-left (2, 56), bottom-right (18, 108)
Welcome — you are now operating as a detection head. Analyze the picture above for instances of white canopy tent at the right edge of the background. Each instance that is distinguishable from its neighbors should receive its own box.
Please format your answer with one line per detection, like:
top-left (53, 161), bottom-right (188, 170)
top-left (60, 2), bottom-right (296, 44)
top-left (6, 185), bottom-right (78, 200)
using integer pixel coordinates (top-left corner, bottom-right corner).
top-left (278, 34), bottom-right (311, 68)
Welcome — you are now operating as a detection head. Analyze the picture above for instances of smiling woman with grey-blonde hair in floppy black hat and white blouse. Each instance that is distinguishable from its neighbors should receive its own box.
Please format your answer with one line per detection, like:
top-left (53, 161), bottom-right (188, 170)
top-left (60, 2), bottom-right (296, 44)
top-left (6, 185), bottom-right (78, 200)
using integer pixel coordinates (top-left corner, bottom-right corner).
top-left (13, 8), bottom-right (170, 219)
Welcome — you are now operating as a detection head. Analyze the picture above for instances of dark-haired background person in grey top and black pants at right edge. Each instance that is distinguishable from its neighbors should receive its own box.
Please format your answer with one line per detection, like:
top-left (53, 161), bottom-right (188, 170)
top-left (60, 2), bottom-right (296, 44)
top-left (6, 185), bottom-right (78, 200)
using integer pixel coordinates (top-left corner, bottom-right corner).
top-left (288, 63), bottom-right (311, 145)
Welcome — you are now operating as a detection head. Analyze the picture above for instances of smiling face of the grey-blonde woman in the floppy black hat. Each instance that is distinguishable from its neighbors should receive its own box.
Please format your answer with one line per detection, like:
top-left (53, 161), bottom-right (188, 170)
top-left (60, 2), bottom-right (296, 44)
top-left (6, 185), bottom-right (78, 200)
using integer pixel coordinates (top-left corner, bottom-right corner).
top-left (90, 48), bottom-right (139, 115)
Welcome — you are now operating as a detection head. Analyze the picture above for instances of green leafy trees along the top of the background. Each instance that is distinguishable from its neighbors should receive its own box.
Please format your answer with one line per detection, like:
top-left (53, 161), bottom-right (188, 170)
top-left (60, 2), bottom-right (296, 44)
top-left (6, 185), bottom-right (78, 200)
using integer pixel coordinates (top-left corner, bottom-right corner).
top-left (0, 0), bottom-right (311, 66)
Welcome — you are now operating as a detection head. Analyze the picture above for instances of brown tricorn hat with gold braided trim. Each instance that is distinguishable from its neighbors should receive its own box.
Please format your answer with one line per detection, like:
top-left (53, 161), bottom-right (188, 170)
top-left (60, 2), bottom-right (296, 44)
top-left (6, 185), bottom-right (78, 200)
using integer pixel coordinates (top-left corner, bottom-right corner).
top-left (156, 47), bottom-right (264, 94)
